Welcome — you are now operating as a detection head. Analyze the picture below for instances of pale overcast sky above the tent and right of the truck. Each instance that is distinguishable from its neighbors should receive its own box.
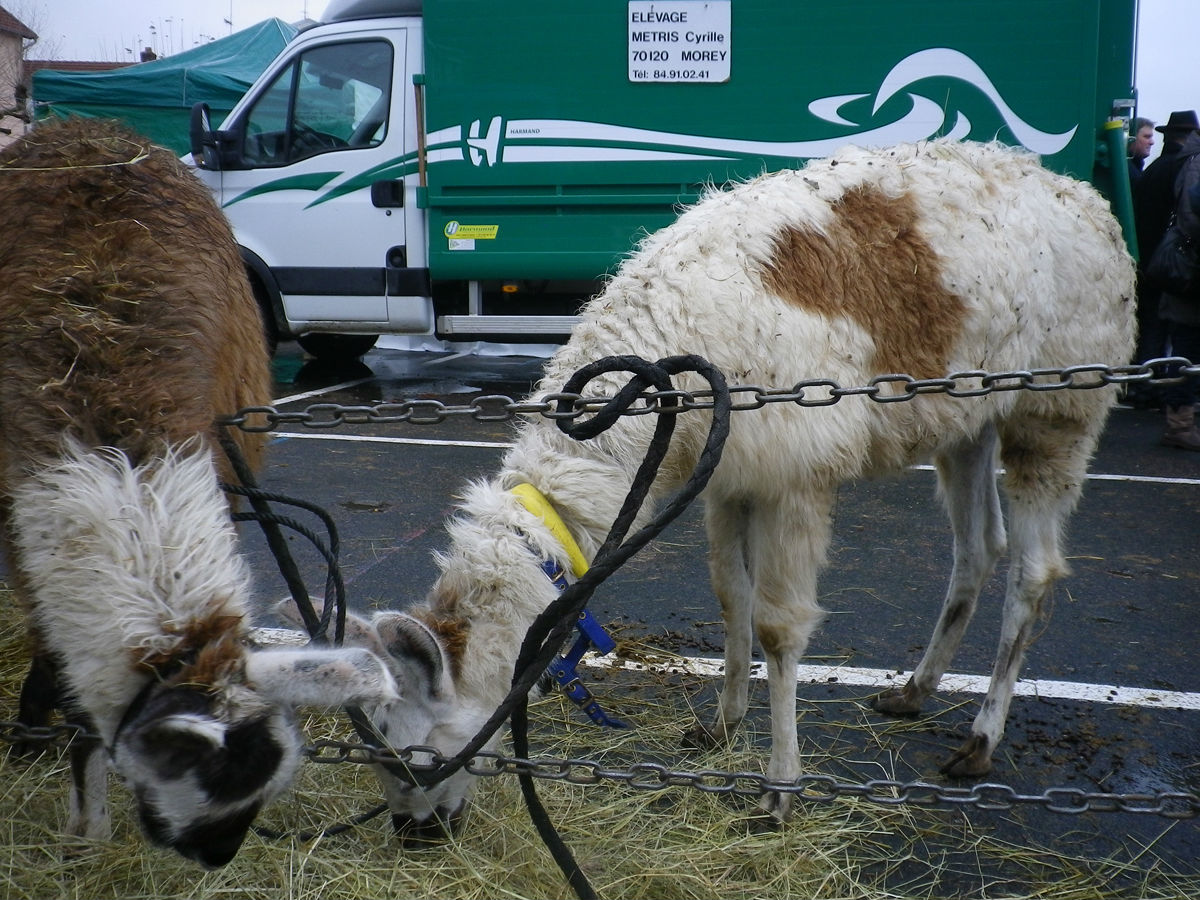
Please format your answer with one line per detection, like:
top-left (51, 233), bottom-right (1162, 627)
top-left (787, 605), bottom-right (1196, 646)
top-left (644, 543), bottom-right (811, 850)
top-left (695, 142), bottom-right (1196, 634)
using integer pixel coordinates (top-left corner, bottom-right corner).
top-left (16, 0), bottom-right (1200, 141)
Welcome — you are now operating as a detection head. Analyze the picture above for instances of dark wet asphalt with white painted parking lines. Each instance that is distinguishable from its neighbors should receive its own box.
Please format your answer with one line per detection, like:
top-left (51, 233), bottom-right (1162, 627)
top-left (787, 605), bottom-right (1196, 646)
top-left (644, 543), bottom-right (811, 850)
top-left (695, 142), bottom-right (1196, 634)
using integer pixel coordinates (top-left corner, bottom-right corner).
top-left (169, 344), bottom-right (1200, 896)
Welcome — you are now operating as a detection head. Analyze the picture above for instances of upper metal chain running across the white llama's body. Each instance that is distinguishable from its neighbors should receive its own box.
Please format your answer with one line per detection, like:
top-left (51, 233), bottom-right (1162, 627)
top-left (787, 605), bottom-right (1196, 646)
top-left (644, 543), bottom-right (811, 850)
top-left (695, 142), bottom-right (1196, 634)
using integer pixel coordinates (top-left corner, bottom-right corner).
top-left (222, 356), bottom-right (1200, 432)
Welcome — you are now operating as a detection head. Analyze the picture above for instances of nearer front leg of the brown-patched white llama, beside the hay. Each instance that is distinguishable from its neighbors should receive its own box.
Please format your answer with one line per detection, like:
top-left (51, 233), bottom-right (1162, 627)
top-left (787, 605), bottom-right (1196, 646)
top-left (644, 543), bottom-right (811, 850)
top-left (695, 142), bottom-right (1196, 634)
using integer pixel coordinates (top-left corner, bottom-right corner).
top-left (746, 492), bottom-right (832, 821)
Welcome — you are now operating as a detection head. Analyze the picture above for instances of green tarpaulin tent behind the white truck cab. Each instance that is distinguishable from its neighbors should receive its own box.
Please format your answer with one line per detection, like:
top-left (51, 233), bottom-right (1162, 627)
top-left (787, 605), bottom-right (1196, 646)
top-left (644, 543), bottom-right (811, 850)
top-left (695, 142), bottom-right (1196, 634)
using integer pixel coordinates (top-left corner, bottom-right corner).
top-left (32, 19), bottom-right (296, 154)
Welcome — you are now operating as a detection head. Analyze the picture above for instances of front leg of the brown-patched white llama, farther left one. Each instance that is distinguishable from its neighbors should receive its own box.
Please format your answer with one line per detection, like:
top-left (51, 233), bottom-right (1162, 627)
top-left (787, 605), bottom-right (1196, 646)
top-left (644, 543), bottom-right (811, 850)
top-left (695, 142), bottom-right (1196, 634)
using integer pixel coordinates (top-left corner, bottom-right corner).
top-left (684, 499), bottom-right (754, 748)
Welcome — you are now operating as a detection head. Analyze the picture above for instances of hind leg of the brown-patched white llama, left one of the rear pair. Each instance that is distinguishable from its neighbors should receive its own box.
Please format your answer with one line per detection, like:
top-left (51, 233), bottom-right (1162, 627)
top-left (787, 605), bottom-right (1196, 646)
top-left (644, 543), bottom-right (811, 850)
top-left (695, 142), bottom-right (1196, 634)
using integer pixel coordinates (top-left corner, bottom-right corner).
top-left (871, 427), bottom-right (1004, 715)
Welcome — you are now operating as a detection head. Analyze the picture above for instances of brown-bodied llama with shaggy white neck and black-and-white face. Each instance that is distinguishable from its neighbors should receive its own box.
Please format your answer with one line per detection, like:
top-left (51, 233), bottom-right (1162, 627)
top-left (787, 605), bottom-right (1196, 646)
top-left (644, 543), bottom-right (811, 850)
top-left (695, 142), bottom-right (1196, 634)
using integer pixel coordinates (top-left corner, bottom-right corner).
top-left (0, 119), bottom-right (394, 866)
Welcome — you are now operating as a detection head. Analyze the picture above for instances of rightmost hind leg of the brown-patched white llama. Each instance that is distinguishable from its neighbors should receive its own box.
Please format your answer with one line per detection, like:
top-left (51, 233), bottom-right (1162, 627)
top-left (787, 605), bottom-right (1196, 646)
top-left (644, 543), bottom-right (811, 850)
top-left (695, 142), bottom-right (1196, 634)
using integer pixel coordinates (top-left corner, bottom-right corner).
top-left (942, 416), bottom-right (1103, 778)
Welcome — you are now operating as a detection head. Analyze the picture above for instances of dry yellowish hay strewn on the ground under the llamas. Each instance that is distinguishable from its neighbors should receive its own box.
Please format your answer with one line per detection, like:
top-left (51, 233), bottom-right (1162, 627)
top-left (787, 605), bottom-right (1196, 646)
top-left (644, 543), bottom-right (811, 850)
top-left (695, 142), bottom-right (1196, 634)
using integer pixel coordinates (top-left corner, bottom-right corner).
top-left (0, 604), bottom-right (1200, 900)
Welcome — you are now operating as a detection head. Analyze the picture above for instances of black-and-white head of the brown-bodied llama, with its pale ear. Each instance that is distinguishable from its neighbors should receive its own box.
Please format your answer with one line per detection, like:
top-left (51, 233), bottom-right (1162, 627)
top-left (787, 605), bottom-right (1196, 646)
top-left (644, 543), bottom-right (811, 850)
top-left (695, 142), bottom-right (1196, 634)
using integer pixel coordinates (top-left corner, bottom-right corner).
top-left (112, 648), bottom-right (396, 868)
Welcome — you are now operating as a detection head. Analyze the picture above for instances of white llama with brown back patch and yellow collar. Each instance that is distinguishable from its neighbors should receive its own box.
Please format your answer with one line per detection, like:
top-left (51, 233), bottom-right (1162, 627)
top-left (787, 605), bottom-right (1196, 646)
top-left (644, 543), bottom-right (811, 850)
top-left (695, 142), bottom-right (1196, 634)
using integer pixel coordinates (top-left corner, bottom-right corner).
top-left (333, 142), bottom-right (1134, 830)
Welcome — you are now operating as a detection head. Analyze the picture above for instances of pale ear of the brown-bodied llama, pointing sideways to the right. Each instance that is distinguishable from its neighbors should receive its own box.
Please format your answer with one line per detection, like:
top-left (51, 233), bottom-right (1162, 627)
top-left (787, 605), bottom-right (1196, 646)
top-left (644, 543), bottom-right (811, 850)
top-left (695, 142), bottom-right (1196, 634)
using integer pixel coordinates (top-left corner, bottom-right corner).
top-left (246, 647), bottom-right (398, 707)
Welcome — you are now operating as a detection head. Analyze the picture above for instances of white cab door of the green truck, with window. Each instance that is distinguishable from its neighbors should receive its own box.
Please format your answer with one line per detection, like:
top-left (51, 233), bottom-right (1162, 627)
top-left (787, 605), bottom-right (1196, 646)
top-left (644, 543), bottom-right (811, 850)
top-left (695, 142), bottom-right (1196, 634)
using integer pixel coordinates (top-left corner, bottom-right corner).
top-left (222, 29), bottom-right (425, 334)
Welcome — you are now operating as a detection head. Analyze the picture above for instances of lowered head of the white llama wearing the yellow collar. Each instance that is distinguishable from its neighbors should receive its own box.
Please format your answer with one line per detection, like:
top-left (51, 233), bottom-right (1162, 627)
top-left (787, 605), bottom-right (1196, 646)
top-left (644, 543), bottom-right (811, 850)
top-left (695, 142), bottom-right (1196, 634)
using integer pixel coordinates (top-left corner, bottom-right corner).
top-left (276, 601), bottom-right (475, 846)
